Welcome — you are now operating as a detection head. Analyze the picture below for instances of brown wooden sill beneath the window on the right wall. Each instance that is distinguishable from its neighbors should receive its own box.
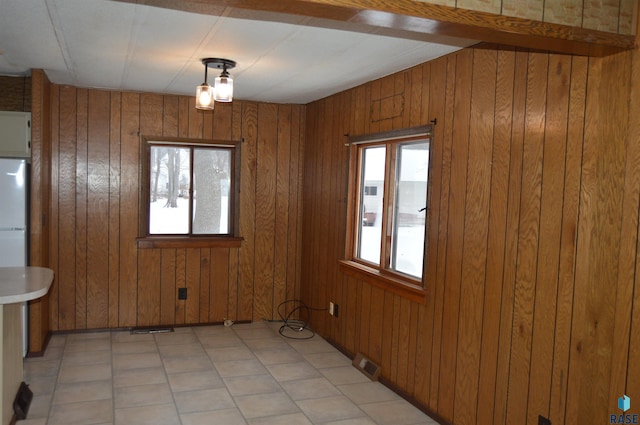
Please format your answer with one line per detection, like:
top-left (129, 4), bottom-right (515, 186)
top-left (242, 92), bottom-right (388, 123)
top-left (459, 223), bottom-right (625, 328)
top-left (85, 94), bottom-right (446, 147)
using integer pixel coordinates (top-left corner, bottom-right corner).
top-left (340, 260), bottom-right (427, 304)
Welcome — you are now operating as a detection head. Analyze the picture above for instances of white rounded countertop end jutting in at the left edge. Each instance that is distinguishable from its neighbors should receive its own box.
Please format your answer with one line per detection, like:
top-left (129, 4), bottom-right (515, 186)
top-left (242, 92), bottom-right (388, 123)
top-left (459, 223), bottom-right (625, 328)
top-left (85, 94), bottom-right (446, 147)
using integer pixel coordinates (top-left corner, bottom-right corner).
top-left (0, 267), bottom-right (53, 304)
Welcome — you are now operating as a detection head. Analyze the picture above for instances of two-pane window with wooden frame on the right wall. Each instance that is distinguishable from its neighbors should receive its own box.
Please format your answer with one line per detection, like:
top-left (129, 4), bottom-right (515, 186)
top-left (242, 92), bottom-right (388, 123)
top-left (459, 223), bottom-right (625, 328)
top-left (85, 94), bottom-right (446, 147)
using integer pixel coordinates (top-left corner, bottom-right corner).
top-left (343, 126), bottom-right (431, 300)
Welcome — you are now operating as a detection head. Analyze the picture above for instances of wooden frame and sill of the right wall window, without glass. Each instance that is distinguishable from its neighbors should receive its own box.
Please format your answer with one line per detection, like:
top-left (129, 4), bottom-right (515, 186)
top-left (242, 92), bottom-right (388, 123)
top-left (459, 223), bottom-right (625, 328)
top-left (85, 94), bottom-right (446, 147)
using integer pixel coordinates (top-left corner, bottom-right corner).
top-left (340, 125), bottom-right (433, 303)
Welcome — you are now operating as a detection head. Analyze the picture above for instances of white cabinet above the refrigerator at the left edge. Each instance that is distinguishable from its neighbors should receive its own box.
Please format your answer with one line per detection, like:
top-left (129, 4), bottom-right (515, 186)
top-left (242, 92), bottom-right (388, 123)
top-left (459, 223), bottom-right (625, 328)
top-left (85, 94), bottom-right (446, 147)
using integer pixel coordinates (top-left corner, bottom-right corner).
top-left (0, 111), bottom-right (31, 158)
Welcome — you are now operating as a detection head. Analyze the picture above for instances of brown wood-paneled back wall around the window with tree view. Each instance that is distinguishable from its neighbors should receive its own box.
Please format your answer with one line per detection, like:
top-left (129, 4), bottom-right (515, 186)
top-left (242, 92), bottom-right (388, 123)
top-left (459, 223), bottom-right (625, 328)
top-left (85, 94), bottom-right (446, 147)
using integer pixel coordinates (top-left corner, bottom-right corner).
top-left (49, 89), bottom-right (305, 331)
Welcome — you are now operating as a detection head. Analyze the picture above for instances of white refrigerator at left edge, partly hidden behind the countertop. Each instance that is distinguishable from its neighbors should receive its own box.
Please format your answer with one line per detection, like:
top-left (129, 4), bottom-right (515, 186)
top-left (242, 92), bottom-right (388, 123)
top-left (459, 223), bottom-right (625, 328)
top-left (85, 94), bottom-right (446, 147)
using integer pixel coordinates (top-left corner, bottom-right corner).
top-left (0, 158), bottom-right (29, 356)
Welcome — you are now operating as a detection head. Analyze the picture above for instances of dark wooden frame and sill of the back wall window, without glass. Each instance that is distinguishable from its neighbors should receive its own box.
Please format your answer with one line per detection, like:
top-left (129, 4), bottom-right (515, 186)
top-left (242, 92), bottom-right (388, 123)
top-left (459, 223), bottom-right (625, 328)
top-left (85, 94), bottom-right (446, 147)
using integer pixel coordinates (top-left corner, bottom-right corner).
top-left (137, 136), bottom-right (243, 248)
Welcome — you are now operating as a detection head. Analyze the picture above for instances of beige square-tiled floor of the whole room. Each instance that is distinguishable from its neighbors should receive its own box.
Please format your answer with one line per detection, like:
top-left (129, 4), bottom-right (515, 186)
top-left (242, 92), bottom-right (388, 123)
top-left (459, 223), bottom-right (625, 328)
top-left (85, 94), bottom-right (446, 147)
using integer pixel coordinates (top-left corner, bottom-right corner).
top-left (17, 323), bottom-right (436, 425)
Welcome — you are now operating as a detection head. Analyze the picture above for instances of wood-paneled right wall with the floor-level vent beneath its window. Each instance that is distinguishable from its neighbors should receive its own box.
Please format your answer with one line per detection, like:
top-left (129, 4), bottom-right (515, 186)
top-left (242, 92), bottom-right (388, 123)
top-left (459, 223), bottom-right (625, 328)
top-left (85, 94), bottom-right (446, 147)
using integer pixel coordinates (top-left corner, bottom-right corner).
top-left (302, 46), bottom-right (640, 425)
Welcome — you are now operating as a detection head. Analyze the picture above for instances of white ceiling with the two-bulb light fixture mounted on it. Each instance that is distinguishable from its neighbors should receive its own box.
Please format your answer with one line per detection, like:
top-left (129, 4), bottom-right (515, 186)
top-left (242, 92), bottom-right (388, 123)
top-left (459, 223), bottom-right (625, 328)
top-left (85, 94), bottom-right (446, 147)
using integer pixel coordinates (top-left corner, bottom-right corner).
top-left (0, 0), bottom-right (474, 104)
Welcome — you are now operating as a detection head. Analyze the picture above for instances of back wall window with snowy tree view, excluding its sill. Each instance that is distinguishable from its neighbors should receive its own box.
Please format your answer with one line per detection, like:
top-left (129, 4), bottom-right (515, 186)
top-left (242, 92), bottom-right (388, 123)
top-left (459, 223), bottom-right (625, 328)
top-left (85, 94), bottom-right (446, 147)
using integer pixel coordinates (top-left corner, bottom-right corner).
top-left (140, 139), bottom-right (240, 246)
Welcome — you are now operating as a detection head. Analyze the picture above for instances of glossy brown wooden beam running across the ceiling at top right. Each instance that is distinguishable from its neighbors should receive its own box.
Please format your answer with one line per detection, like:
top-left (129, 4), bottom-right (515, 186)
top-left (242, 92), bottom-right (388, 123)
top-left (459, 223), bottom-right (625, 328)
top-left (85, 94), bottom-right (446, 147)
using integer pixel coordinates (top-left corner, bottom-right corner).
top-left (120, 0), bottom-right (636, 56)
